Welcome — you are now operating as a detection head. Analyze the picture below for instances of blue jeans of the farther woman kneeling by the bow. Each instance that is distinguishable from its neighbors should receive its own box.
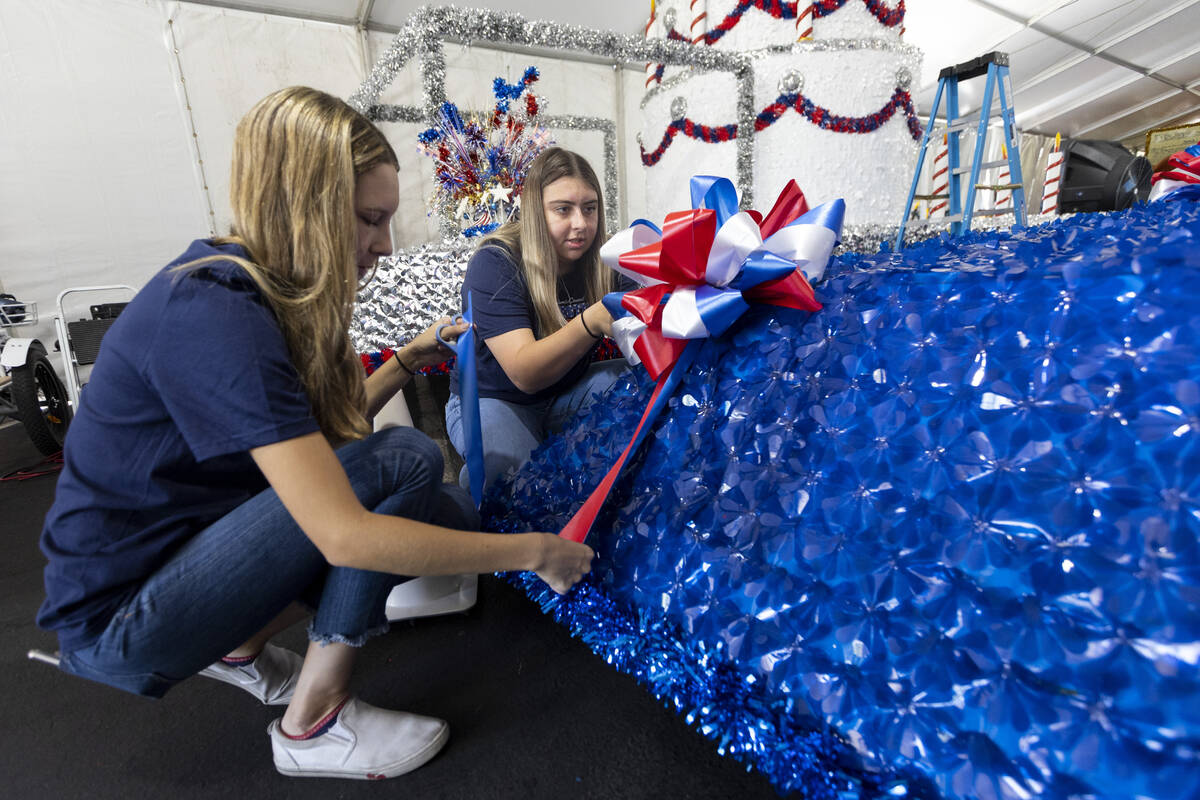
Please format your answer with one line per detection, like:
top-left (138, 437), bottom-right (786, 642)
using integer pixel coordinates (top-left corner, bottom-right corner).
top-left (446, 359), bottom-right (629, 488)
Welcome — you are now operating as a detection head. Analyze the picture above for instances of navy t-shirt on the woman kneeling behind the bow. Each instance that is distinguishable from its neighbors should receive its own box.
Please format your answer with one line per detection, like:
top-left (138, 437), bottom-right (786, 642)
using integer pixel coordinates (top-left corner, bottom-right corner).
top-left (450, 245), bottom-right (592, 405)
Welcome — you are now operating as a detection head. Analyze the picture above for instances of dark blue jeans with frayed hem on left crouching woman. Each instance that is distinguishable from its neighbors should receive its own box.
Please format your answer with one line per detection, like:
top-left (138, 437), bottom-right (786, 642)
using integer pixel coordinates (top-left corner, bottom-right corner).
top-left (60, 427), bottom-right (479, 697)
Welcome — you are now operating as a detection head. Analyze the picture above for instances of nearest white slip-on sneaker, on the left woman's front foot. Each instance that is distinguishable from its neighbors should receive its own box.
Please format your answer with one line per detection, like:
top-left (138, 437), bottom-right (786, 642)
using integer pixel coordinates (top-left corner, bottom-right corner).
top-left (266, 697), bottom-right (450, 781)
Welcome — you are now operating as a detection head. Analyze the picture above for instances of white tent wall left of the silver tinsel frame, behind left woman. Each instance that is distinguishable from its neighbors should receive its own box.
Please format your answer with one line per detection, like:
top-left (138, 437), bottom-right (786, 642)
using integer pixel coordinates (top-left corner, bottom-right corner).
top-left (0, 0), bottom-right (365, 352)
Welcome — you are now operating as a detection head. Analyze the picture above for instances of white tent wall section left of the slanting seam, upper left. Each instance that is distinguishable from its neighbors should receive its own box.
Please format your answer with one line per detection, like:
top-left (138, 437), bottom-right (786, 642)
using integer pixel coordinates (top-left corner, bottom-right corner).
top-left (0, 0), bottom-right (208, 352)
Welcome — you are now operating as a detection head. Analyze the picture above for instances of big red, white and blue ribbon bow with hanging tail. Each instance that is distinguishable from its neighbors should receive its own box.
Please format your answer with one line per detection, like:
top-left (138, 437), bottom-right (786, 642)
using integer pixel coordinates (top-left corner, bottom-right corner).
top-left (559, 175), bottom-right (846, 542)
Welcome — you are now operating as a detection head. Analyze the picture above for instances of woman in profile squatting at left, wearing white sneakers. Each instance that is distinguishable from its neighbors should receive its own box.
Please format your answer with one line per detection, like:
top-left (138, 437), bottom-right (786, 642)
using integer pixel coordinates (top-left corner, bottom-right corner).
top-left (38, 88), bottom-right (592, 778)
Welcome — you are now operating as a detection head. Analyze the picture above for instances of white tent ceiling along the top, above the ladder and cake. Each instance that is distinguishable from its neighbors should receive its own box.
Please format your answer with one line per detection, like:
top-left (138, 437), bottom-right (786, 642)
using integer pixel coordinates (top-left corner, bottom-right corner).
top-left (187, 0), bottom-right (1200, 146)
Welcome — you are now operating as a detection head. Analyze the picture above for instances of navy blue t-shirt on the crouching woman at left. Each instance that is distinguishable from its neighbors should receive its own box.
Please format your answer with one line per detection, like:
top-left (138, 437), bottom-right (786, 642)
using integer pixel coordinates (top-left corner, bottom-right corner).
top-left (37, 240), bottom-right (319, 650)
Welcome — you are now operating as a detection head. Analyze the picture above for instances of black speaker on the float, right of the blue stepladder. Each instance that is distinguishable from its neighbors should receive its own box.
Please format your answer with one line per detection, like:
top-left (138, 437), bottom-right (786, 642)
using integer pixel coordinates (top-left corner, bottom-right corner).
top-left (1058, 139), bottom-right (1151, 213)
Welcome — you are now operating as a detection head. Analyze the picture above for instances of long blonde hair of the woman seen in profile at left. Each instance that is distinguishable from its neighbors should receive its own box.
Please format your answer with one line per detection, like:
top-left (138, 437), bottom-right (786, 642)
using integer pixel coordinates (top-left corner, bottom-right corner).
top-left (186, 86), bottom-right (400, 441)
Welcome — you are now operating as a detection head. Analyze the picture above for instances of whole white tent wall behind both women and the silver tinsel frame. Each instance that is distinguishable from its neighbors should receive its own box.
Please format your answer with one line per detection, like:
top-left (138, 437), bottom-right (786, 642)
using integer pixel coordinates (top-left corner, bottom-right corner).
top-left (0, 0), bottom-right (644, 363)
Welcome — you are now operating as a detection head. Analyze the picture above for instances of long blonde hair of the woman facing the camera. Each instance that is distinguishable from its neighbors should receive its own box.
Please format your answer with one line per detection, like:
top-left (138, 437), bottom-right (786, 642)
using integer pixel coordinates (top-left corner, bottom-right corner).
top-left (480, 148), bottom-right (614, 337)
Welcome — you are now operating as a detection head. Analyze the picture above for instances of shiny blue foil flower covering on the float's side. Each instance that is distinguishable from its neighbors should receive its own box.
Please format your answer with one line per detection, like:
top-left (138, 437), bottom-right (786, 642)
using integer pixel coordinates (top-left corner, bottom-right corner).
top-left (484, 199), bottom-right (1200, 799)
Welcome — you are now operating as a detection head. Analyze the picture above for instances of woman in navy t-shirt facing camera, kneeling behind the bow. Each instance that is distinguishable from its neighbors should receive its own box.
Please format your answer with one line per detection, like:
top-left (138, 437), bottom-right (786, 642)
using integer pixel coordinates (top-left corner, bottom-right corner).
top-left (446, 148), bottom-right (626, 485)
